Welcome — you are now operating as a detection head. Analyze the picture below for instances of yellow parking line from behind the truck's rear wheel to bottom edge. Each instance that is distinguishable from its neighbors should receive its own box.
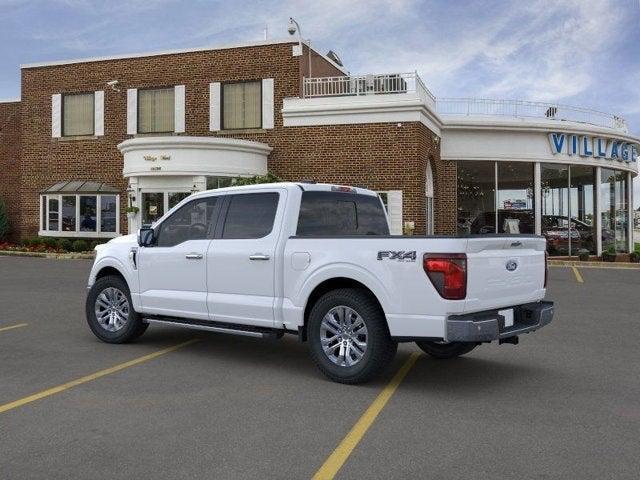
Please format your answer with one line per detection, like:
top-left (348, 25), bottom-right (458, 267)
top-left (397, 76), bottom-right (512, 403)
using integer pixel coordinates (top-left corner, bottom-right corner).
top-left (313, 352), bottom-right (420, 480)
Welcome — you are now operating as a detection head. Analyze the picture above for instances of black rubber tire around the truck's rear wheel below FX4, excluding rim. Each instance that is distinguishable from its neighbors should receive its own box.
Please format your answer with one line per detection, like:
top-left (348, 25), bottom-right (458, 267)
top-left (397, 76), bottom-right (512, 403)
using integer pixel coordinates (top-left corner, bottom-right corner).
top-left (307, 288), bottom-right (398, 384)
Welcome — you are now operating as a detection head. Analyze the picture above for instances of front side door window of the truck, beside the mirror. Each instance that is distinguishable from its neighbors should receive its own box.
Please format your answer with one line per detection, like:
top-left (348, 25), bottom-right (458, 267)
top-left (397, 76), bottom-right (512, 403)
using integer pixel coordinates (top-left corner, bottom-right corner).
top-left (157, 197), bottom-right (217, 247)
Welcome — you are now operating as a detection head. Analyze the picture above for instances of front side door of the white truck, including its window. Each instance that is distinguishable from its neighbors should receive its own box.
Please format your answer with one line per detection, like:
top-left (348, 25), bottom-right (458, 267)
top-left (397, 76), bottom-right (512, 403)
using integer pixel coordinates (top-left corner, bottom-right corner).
top-left (138, 197), bottom-right (218, 320)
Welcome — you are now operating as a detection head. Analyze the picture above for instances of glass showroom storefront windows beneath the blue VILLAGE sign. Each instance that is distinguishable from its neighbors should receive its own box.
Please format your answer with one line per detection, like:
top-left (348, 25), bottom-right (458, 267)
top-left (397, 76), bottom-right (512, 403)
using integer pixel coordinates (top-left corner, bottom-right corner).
top-left (457, 161), bottom-right (630, 255)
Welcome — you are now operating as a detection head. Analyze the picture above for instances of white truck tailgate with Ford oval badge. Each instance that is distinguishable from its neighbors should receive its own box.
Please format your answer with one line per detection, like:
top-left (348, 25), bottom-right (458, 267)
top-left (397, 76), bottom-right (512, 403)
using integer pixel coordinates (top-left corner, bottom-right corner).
top-left (464, 236), bottom-right (546, 312)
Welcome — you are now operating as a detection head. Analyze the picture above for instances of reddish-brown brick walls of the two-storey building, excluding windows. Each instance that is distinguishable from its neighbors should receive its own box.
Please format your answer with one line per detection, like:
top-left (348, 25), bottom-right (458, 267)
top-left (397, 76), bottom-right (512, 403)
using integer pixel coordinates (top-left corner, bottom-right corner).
top-left (0, 42), bottom-right (455, 236)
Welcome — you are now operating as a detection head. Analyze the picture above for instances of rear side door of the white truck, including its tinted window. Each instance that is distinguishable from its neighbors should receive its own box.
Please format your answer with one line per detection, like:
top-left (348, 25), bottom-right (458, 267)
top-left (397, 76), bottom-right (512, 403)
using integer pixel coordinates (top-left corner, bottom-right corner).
top-left (207, 190), bottom-right (286, 327)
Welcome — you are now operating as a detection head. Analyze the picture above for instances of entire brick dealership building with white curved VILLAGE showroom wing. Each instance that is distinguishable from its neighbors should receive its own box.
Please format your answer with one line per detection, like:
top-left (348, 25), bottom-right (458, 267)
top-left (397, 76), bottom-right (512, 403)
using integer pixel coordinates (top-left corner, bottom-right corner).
top-left (0, 40), bottom-right (638, 253)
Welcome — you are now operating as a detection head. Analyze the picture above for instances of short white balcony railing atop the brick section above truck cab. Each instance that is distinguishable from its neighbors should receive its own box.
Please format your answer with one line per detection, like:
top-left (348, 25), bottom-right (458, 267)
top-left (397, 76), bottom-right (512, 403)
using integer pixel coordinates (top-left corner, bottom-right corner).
top-left (303, 72), bottom-right (435, 105)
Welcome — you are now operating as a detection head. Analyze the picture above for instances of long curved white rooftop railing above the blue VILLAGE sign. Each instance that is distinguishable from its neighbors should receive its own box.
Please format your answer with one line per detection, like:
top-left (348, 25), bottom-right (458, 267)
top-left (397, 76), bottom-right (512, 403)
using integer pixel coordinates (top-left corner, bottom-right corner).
top-left (436, 98), bottom-right (628, 132)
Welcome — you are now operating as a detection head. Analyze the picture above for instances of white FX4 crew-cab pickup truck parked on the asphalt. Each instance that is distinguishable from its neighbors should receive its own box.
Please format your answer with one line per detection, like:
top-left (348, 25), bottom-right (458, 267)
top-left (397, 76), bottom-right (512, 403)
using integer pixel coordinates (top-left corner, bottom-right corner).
top-left (86, 183), bottom-right (553, 383)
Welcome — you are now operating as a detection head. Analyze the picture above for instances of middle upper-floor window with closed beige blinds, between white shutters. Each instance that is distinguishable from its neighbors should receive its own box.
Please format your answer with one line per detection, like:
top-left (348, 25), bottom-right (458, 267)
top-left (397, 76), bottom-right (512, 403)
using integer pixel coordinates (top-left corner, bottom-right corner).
top-left (138, 87), bottom-right (175, 133)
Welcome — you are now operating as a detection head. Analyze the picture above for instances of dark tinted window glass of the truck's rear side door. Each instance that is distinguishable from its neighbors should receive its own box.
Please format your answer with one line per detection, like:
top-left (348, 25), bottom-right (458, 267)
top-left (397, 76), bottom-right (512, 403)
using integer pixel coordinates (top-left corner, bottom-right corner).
top-left (222, 193), bottom-right (278, 238)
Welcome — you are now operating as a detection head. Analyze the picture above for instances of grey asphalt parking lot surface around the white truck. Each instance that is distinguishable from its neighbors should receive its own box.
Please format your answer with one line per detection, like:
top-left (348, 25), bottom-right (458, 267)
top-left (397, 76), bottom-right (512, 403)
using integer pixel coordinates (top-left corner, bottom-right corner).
top-left (0, 257), bottom-right (640, 479)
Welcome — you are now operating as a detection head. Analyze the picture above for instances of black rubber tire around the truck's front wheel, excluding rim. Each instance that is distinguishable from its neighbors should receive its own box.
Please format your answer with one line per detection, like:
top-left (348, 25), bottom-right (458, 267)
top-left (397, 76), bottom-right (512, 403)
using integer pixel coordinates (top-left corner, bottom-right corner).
top-left (85, 275), bottom-right (149, 343)
